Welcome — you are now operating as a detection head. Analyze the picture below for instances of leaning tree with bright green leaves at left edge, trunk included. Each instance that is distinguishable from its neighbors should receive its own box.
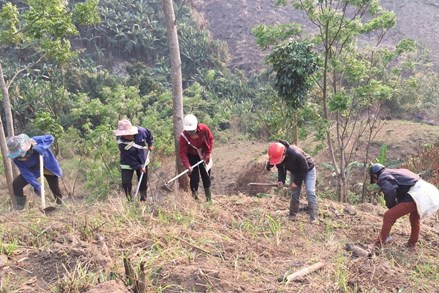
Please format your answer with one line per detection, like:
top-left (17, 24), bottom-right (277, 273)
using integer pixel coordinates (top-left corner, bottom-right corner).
top-left (0, 0), bottom-right (99, 206)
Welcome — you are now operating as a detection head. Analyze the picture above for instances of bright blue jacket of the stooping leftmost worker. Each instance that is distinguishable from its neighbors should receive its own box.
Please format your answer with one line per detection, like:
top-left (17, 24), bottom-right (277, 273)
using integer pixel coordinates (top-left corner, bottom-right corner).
top-left (14, 134), bottom-right (62, 194)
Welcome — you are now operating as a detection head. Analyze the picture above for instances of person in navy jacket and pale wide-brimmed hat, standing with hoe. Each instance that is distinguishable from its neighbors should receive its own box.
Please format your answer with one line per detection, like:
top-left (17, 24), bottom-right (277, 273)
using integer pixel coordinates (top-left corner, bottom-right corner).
top-left (114, 119), bottom-right (154, 201)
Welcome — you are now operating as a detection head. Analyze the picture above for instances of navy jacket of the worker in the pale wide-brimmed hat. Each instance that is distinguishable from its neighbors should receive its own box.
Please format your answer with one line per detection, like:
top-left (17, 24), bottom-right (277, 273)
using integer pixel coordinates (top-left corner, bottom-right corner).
top-left (118, 126), bottom-right (154, 170)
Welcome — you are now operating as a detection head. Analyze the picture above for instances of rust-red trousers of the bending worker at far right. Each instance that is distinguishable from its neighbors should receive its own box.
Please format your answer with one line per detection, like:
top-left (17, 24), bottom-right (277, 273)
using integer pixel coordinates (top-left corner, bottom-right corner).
top-left (375, 202), bottom-right (421, 247)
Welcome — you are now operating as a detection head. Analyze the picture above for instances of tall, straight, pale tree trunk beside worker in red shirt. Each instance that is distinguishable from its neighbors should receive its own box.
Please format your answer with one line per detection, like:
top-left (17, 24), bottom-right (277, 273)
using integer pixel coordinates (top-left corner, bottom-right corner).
top-left (162, 0), bottom-right (189, 191)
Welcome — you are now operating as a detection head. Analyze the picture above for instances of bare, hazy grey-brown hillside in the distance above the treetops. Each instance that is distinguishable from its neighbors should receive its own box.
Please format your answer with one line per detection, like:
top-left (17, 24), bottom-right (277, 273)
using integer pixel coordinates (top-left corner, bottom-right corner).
top-left (192, 0), bottom-right (439, 72)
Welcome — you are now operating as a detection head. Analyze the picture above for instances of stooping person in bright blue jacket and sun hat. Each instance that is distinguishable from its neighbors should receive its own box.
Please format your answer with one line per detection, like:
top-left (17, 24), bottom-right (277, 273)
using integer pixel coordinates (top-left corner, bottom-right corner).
top-left (7, 133), bottom-right (62, 210)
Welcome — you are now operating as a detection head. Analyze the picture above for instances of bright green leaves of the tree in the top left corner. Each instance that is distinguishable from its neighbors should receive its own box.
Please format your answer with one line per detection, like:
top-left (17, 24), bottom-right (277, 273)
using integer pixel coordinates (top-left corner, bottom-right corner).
top-left (0, 0), bottom-right (97, 62)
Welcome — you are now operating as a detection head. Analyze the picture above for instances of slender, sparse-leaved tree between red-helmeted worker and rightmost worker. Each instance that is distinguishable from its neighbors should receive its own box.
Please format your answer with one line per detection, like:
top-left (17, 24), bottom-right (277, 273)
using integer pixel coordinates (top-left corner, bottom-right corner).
top-left (276, 0), bottom-right (413, 201)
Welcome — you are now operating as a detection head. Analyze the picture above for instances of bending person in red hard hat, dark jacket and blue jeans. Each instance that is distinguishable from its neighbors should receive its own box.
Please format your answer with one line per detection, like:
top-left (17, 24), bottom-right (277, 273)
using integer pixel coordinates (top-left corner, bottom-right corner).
top-left (267, 140), bottom-right (318, 223)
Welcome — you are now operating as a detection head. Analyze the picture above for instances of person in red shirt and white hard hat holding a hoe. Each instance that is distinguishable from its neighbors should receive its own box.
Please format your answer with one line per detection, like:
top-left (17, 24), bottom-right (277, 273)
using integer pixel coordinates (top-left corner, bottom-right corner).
top-left (179, 114), bottom-right (214, 201)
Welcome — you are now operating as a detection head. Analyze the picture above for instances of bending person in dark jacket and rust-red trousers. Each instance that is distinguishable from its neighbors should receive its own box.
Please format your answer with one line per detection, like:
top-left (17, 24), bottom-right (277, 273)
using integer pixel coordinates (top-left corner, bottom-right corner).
top-left (369, 164), bottom-right (421, 248)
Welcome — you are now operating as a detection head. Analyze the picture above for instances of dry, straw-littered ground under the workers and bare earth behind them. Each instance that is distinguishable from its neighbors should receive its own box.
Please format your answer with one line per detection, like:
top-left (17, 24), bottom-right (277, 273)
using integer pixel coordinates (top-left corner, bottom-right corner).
top-left (0, 121), bottom-right (439, 293)
